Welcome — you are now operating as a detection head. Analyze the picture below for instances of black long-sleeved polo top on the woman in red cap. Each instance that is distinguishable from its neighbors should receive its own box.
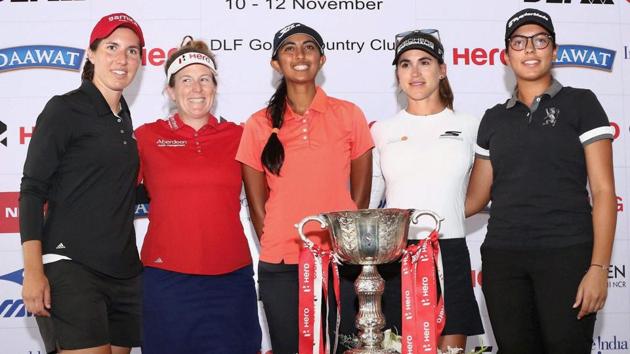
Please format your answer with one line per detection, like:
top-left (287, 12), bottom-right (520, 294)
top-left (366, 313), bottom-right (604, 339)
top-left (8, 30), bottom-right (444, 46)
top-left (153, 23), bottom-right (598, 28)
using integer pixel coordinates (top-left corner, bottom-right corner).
top-left (20, 81), bottom-right (142, 278)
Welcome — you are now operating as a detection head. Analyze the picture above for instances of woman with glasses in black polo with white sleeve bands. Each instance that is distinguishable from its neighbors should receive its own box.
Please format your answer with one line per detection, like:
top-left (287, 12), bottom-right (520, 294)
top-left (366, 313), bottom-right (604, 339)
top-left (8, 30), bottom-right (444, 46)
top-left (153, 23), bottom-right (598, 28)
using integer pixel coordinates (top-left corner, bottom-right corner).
top-left (466, 9), bottom-right (617, 354)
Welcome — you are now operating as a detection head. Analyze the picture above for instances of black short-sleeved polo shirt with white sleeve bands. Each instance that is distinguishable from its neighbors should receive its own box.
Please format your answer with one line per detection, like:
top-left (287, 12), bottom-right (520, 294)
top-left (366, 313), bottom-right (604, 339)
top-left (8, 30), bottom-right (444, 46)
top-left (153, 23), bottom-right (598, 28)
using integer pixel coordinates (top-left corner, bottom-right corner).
top-left (476, 80), bottom-right (613, 249)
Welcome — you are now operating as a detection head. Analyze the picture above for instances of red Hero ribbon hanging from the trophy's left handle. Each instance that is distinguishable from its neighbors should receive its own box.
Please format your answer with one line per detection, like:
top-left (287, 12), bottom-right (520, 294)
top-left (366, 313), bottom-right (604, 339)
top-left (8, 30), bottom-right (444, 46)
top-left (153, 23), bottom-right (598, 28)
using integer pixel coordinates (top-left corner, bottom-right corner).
top-left (298, 245), bottom-right (341, 354)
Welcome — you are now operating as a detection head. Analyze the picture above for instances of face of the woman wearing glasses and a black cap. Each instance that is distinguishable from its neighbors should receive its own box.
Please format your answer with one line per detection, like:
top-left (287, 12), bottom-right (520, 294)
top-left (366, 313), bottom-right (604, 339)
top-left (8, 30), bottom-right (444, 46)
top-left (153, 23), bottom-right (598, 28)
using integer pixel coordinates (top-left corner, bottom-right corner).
top-left (505, 24), bottom-right (558, 81)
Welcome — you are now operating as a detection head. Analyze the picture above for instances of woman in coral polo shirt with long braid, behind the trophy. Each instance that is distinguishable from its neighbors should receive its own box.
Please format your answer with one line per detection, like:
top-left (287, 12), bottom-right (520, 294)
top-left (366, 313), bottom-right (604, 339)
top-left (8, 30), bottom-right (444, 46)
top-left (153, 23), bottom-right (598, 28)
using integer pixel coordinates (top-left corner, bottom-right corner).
top-left (236, 23), bottom-right (374, 354)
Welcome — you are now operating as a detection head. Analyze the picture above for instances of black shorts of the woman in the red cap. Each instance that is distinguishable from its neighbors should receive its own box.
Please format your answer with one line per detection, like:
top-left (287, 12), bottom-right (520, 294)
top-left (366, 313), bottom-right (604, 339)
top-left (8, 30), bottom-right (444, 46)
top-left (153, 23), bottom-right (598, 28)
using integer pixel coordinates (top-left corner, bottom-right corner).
top-left (37, 260), bottom-right (142, 352)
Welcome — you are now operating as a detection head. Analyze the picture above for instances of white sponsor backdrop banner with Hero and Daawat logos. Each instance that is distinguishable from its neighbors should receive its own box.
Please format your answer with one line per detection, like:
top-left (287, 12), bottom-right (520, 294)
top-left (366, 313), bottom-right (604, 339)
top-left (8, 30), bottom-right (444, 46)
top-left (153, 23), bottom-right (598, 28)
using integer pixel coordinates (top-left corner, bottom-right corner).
top-left (0, 0), bottom-right (630, 354)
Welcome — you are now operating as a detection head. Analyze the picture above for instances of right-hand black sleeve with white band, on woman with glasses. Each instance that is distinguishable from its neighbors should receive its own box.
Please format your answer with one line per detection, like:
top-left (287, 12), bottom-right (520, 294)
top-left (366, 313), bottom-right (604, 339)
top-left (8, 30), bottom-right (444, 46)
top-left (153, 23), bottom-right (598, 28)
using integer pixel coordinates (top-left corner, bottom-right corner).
top-left (578, 90), bottom-right (614, 146)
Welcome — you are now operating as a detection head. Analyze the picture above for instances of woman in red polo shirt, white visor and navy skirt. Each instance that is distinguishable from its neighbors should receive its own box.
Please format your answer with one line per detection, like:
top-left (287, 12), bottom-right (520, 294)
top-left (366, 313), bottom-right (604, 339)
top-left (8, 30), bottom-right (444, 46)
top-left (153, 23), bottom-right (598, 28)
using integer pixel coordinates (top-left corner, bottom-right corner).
top-left (136, 36), bottom-right (261, 354)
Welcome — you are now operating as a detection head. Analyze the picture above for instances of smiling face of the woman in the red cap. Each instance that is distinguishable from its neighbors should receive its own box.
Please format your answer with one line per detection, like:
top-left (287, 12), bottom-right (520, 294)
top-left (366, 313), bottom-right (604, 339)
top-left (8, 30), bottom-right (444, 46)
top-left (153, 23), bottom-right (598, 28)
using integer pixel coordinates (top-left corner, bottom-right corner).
top-left (88, 27), bottom-right (141, 97)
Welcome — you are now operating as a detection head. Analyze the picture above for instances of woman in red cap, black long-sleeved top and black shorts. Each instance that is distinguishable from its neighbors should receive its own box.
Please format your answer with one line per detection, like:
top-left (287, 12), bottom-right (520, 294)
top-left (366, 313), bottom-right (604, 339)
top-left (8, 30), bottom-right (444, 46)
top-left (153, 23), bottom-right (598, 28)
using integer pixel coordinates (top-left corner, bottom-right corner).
top-left (20, 13), bottom-right (144, 354)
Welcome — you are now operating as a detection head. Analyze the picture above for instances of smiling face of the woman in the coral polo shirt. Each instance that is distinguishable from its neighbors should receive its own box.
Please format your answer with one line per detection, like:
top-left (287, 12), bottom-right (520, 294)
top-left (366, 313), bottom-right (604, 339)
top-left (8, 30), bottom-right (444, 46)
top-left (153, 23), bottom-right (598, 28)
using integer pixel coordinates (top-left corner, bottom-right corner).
top-left (271, 33), bottom-right (326, 83)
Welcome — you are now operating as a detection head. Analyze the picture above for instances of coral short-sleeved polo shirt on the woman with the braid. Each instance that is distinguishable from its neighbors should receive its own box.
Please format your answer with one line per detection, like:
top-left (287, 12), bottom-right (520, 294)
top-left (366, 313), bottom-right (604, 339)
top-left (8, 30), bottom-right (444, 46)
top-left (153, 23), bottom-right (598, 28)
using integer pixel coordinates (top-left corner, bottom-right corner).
top-left (236, 87), bottom-right (374, 264)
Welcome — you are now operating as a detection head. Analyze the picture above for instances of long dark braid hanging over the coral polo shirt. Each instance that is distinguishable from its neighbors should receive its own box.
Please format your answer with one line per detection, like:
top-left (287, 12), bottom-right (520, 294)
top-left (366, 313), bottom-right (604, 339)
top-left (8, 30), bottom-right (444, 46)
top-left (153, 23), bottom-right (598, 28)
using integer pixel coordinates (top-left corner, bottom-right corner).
top-left (260, 77), bottom-right (287, 176)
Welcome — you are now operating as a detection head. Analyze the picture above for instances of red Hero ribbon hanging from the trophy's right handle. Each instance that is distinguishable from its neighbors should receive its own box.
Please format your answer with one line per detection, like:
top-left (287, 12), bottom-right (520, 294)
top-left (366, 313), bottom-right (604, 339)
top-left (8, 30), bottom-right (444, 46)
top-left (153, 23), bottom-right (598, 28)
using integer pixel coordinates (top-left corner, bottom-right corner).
top-left (401, 230), bottom-right (446, 354)
